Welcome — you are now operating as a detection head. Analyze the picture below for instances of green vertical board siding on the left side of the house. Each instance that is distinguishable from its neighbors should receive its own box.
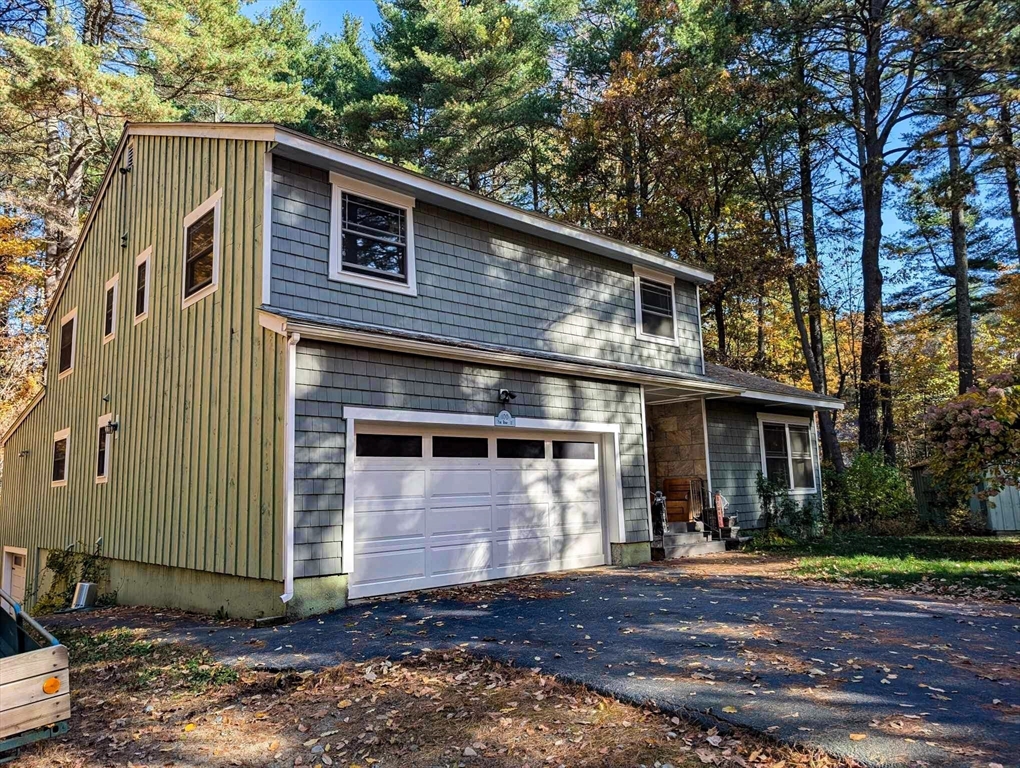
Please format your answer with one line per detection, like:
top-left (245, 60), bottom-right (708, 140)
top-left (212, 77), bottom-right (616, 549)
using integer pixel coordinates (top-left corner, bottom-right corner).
top-left (0, 136), bottom-right (286, 580)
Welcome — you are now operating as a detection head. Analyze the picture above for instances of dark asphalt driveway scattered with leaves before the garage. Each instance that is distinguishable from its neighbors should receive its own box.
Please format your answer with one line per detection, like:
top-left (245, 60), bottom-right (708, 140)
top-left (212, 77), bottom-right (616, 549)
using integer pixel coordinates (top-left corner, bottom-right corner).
top-left (131, 565), bottom-right (1020, 766)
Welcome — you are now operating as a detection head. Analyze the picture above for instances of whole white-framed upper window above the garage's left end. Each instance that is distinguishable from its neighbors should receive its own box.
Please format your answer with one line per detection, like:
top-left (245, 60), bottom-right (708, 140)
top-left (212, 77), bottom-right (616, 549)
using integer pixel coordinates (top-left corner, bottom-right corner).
top-left (329, 173), bottom-right (417, 296)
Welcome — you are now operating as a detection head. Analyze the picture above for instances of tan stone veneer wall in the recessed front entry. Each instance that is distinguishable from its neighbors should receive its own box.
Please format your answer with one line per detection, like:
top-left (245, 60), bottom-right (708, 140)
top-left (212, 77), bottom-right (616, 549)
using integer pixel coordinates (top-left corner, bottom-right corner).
top-left (647, 400), bottom-right (708, 492)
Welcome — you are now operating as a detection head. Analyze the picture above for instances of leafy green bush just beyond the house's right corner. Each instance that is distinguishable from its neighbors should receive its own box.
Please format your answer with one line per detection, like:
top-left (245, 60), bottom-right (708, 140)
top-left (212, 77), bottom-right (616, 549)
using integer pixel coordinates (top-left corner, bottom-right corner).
top-left (823, 451), bottom-right (917, 533)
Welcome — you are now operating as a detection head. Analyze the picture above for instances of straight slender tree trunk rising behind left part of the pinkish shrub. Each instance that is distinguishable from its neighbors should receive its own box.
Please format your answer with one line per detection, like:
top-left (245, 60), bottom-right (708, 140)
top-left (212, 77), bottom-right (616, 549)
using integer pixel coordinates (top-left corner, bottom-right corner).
top-left (946, 87), bottom-right (974, 394)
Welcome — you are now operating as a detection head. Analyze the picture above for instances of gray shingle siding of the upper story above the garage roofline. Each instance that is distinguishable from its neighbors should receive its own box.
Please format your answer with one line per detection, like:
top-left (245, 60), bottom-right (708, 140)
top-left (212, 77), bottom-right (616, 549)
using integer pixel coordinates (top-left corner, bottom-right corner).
top-left (271, 157), bottom-right (701, 373)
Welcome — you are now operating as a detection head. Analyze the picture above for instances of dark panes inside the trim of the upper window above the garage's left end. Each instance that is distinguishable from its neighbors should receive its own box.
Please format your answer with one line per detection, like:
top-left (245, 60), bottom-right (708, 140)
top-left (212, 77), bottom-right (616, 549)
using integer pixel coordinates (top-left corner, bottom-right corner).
top-left (341, 192), bottom-right (407, 280)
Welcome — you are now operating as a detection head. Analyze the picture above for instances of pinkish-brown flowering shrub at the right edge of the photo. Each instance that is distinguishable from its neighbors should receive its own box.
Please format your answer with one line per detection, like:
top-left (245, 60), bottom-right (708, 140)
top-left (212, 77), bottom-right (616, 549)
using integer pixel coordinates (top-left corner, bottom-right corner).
top-left (925, 368), bottom-right (1020, 499)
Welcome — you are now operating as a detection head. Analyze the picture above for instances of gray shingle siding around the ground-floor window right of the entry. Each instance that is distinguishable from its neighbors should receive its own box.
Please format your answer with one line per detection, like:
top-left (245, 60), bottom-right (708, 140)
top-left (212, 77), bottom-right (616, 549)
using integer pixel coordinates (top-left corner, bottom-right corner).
top-left (705, 400), bottom-right (821, 528)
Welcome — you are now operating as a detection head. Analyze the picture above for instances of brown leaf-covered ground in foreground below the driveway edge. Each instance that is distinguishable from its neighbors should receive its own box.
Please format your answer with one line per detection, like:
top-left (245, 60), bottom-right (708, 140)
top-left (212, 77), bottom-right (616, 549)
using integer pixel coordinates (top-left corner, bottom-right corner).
top-left (18, 629), bottom-right (850, 768)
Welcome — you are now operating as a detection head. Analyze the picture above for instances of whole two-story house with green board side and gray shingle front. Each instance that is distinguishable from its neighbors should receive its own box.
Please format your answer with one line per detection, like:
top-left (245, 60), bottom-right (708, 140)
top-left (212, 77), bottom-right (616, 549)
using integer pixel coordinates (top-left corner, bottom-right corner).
top-left (0, 123), bottom-right (842, 616)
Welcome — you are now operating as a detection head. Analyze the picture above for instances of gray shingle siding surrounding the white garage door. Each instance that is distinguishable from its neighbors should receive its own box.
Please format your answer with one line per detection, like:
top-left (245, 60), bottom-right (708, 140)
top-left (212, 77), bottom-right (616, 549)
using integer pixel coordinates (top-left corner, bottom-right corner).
top-left (294, 342), bottom-right (649, 578)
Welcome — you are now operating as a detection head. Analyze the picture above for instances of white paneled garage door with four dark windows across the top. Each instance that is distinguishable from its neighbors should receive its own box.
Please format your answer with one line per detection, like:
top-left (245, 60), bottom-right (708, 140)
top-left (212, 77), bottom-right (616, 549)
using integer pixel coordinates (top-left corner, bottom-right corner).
top-left (348, 424), bottom-right (607, 598)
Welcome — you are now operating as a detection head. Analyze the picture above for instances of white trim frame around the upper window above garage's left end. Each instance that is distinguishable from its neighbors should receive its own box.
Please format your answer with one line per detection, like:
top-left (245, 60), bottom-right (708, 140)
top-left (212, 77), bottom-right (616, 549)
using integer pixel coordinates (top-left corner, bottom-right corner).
top-left (329, 172), bottom-right (418, 296)
